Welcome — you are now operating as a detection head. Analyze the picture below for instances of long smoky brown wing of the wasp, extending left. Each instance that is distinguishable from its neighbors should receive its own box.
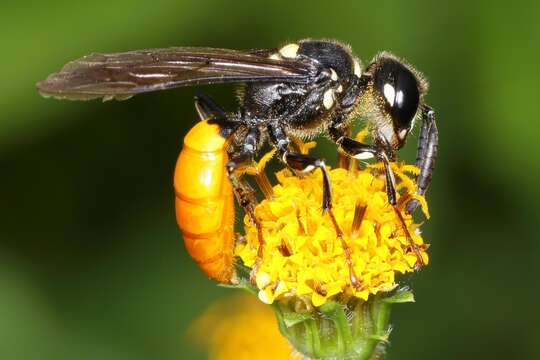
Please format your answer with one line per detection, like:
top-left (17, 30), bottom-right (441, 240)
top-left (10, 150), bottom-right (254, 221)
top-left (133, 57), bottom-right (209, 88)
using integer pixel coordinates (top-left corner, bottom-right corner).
top-left (37, 47), bottom-right (313, 100)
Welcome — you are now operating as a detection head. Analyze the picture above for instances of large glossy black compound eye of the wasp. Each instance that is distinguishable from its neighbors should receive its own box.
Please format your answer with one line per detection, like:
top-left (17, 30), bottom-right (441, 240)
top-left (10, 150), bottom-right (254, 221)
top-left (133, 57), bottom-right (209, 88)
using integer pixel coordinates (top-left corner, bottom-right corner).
top-left (374, 59), bottom-right (420, 131)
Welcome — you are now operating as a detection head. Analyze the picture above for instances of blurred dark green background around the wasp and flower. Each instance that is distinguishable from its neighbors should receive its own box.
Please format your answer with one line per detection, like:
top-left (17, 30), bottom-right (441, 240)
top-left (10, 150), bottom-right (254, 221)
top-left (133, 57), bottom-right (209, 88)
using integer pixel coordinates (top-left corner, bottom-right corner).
top-left (0, 0), bottom-right (540, 360)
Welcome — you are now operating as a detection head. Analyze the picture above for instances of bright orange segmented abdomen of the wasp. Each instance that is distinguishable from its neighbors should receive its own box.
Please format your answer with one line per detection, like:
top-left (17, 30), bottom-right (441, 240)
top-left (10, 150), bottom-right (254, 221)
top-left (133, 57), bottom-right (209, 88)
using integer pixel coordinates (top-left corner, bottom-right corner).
top-left (174, 121), bottom-right (234, 283)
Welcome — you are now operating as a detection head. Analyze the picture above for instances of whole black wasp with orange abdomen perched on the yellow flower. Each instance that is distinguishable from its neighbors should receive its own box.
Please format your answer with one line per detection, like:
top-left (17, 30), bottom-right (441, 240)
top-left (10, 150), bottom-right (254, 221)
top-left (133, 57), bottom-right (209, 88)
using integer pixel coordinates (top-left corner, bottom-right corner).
top-left (37, 39), bottom-right (439, 282)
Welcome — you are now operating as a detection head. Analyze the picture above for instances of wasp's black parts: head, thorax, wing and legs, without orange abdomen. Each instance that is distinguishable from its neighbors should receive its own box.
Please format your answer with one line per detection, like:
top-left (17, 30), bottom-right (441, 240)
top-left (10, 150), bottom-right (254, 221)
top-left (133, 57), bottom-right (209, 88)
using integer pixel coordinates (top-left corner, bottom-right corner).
top-left (38, 39), bottom-right (438, 280)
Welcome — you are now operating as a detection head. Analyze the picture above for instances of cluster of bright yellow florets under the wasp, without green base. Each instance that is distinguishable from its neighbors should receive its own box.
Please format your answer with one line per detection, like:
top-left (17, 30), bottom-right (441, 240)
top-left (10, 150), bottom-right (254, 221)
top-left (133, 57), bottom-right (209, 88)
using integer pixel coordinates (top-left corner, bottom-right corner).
top-left (235, 157), bottom-right (429, 307)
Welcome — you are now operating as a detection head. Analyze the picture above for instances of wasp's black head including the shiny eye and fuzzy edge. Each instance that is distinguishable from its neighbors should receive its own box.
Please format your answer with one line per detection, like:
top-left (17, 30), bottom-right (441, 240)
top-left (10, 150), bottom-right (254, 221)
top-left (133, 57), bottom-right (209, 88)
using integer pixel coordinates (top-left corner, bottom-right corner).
top-left (367, 53), bottom-right (427, 148)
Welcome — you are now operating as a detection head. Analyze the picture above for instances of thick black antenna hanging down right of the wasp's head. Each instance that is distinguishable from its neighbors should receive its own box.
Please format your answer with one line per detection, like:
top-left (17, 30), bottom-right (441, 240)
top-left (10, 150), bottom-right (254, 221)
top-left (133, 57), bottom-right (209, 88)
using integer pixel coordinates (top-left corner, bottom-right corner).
top-left (407, 105), bottom-right (439, 214)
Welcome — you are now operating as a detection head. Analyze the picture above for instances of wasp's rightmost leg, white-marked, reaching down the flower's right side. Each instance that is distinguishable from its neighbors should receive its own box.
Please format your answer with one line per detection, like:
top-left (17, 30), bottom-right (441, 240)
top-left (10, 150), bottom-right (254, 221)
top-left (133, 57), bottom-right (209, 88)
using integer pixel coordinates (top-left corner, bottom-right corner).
top-left (330, 129), bottom-right (425, 266)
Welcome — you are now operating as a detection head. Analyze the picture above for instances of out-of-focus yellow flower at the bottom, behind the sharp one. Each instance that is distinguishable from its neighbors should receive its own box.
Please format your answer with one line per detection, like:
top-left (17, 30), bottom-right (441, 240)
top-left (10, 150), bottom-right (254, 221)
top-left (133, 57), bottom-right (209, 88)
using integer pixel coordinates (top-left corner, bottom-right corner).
top-left (190, 295), bottom-right (301, 360)
